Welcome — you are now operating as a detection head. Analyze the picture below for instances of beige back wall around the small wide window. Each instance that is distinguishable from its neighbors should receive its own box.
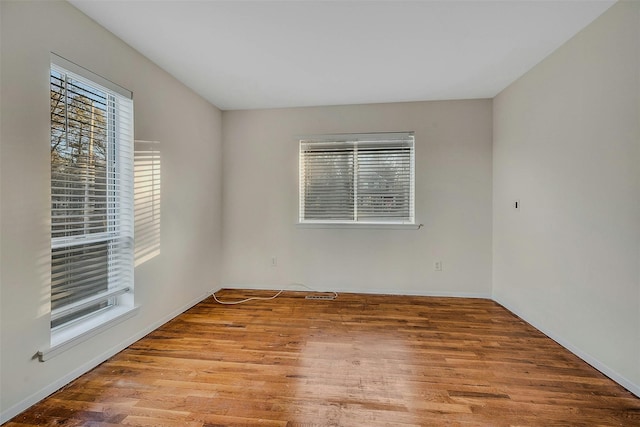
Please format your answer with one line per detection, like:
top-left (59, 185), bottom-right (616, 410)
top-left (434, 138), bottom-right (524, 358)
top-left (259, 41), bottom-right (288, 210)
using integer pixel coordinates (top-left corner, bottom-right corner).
top-left (222, 100), bottom-right (492, 296)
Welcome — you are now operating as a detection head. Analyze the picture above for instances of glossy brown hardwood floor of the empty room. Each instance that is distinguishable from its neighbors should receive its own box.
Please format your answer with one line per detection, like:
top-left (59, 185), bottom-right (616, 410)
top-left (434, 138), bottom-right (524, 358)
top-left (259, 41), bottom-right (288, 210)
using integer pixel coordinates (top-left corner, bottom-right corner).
top-left (6, 290), bottom-right (640, 427)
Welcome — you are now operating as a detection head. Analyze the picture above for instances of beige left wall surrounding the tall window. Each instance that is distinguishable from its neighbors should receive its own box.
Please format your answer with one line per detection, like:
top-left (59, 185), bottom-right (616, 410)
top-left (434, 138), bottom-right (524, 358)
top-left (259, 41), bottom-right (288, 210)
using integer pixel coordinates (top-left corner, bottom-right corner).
top-left (0, 1), bottom-right (222, 420)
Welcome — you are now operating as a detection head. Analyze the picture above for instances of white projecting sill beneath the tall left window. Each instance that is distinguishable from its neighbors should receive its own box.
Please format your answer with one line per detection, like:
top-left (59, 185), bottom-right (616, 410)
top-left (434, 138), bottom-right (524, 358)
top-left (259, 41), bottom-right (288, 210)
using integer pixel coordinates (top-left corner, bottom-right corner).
top-left (37, 306), bottom-right (140, 362)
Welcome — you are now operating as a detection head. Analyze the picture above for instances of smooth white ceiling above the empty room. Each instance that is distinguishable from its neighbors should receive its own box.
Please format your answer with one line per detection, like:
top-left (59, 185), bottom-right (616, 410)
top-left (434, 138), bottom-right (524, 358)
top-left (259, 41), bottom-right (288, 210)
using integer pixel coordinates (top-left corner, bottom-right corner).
top-left (70, 0), bottom-right (615, 110)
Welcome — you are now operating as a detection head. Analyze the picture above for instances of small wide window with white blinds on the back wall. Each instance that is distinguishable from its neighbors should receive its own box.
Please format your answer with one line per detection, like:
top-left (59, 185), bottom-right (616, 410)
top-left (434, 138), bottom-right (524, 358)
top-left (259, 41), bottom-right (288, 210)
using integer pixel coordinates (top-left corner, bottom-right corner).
top-left (299, 132), bottom-right (415, 224)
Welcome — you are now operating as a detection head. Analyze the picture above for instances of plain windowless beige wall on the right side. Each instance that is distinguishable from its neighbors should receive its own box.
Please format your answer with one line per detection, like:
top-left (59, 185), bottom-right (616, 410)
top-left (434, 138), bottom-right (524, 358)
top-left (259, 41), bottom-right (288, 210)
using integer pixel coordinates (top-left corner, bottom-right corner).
top-left (493, 2), bottom-right (640, 395)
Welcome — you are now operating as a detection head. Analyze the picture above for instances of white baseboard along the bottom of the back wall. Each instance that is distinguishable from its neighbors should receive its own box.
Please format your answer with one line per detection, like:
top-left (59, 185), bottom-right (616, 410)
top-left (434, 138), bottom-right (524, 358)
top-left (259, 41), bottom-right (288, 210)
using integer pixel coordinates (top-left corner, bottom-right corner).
top-left (221, 283), bottom-right (491, 299)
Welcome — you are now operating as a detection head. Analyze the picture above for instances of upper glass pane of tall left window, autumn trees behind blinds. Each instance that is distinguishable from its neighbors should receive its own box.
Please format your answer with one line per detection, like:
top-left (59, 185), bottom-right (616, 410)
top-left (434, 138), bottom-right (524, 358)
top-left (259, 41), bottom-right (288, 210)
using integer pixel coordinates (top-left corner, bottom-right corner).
top-left (51, 71), bottom-right (109, 238)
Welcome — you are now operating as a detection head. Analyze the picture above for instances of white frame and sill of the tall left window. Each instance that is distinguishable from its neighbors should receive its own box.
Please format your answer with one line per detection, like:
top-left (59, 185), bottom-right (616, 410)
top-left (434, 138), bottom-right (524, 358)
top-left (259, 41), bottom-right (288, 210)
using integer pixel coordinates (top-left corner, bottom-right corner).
top-left (44, 53), bottom-right (137, 361)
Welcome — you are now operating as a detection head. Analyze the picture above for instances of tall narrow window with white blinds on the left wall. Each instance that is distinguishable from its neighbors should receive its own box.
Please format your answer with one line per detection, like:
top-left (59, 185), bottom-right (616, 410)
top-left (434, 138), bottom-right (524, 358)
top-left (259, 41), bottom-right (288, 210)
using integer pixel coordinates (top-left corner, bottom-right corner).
top-left (50, 57), bottom-right (133, 329)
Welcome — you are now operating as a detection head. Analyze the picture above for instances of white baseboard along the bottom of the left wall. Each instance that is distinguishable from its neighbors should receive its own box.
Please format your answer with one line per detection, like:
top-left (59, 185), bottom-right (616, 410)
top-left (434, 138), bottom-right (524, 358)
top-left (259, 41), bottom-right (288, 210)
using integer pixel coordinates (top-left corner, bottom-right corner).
top-left (0, 292), bottom-right (210, 424)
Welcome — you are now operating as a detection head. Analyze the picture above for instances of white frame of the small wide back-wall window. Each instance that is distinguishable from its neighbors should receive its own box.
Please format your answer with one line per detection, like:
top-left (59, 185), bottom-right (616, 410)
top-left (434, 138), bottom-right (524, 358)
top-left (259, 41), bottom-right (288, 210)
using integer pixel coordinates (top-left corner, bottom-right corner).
top-left (297, 132), bottom-right (418, 228)
